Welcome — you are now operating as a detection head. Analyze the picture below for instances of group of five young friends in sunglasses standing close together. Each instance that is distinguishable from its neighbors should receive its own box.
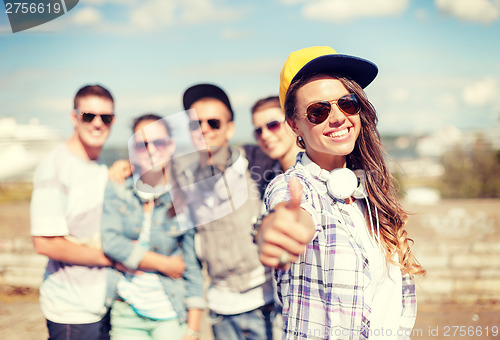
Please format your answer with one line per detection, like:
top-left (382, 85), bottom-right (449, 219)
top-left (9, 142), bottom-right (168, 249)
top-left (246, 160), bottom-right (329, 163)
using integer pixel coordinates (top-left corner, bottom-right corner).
top-left (31, 46), bottom-right (425, 340)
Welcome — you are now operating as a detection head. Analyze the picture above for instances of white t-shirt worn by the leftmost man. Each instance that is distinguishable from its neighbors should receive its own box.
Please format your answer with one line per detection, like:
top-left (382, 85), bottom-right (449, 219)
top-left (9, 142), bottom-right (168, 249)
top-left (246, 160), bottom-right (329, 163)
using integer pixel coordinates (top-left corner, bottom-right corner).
top-left (31, 144), bottom-right (107, 324)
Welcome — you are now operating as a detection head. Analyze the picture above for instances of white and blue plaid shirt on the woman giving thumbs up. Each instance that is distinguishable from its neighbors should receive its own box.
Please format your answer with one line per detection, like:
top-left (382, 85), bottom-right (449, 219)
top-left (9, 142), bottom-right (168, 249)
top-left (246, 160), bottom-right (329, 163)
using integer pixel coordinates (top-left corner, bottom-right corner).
top-left (264, 154), bottom-right (417, 339)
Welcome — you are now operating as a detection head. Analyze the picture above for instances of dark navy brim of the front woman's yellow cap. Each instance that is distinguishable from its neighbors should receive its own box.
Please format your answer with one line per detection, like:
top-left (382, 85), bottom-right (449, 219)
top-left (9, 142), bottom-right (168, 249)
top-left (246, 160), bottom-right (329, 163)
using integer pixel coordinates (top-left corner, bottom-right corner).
top-left (290, 54), bottom-right (378, 88)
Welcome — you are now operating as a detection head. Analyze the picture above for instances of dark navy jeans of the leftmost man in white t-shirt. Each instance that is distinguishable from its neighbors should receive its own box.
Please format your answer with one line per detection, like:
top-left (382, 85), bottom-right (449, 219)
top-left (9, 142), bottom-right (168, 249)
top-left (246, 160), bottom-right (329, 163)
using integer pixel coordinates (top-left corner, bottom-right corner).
top-left (47, 312), bottom-right (111, 340)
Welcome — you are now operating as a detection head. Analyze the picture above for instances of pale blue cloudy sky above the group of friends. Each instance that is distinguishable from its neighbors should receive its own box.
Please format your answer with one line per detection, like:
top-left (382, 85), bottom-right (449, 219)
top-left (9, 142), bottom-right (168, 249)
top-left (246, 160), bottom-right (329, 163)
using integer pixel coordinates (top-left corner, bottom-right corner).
top-left (0, 0), bottom-right (500, 146)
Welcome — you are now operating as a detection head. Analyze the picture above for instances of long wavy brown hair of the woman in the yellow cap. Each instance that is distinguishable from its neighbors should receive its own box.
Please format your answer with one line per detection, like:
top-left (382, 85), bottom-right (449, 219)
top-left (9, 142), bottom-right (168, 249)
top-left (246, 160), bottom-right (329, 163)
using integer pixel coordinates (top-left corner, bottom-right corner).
top-left (284, 74), bottom-right (425, 275)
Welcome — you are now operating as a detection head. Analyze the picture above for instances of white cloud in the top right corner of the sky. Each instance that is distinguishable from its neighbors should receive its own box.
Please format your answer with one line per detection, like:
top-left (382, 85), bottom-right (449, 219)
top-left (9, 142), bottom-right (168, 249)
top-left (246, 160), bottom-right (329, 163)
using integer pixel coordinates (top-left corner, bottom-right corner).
top-left (435, 0), bottom-right (500, 24)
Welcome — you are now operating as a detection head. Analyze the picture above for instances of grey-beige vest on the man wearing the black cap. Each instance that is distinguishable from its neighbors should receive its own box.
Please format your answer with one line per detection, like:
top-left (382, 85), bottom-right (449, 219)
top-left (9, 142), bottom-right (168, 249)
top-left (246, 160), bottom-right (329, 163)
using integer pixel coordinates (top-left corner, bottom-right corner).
top-left (182, 148), bottom-right (265, 292)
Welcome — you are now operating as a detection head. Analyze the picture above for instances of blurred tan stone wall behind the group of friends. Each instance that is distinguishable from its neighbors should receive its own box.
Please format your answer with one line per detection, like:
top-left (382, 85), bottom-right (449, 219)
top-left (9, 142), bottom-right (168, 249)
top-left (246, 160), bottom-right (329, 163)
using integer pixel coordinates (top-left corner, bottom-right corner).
top-left (0, 200), bottom-right (500, 304)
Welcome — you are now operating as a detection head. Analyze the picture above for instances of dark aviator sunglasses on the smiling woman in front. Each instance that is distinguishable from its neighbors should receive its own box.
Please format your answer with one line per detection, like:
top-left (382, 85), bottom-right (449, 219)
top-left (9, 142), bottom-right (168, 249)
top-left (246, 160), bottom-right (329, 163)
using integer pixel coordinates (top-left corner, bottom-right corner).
top-left (306, 93), bottom-right (361, 124)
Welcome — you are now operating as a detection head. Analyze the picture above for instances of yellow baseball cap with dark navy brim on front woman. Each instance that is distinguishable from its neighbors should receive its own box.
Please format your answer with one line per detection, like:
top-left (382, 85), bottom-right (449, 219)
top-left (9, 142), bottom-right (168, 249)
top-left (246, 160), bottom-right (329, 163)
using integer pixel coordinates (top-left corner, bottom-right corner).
top-left (279, 46), bottom-right (378, 109)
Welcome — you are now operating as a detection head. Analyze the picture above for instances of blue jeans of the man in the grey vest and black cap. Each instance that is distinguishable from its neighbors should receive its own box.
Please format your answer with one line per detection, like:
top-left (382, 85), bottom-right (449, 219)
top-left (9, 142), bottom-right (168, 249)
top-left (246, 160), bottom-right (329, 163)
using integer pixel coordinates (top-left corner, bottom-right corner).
top-left (210, 303), bottom-right (274, 340)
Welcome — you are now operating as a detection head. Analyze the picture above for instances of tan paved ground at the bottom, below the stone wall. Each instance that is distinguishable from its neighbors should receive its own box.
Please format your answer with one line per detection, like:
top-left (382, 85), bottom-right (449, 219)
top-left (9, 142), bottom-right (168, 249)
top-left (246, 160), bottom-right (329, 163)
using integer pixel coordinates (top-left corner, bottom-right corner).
top-left (0, 287), bottom-right (500, 340)
